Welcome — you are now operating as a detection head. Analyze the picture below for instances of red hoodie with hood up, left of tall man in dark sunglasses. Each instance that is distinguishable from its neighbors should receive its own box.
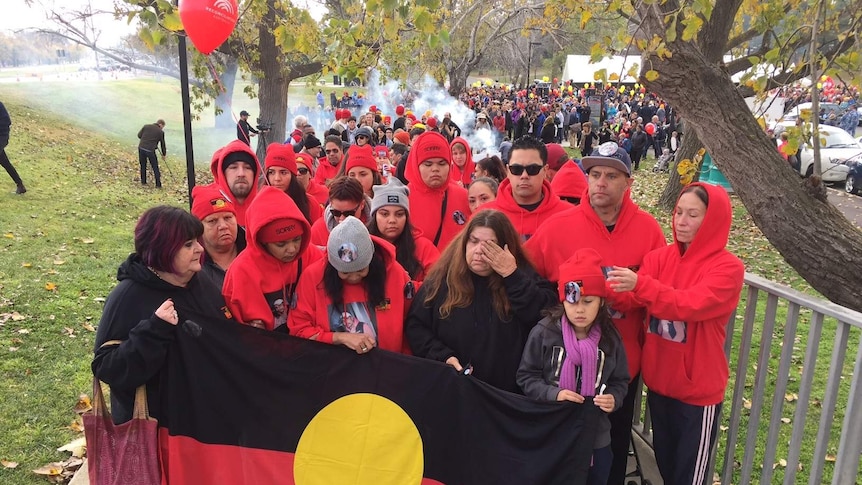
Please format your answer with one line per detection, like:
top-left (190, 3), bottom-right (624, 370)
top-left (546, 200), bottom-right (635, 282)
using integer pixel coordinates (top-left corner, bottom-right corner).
top-left (404, 131), bottom-right (470, 252)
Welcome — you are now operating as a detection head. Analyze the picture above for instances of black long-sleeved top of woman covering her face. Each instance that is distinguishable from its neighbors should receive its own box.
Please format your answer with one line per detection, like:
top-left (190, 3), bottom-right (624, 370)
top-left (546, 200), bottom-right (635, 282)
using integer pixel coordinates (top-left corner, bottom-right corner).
top-left (404, 268), bottom-right (557, 393)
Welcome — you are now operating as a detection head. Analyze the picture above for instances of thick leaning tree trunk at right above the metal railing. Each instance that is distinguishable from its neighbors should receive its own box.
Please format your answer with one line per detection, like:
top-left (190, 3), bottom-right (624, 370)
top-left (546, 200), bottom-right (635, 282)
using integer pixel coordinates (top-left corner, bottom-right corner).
top-left (643, 29), bottom-right (862, 311)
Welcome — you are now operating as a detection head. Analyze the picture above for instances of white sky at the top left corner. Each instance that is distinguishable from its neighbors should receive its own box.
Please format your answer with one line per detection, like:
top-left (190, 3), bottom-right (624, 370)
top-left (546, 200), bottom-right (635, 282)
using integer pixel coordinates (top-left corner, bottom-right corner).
top-left (0, 0), bottom-right (134, 44)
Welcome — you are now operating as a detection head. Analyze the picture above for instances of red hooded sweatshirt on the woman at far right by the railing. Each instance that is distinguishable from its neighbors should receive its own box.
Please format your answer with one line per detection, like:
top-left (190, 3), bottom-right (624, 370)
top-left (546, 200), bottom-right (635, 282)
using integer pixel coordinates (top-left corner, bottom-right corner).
top-left (631, 182), bottom-right (745, 406)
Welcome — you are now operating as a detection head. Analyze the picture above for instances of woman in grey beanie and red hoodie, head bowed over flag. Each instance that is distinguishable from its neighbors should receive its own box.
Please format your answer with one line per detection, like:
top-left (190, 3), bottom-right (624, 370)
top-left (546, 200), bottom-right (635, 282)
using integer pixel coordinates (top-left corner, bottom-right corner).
top-left (287, 217), bottom-right (413, 354)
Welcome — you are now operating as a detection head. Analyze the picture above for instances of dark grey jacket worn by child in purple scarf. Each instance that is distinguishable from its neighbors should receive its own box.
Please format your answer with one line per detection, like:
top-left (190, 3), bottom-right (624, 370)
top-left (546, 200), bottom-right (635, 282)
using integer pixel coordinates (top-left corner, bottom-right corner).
top-left (518, 317), bottom-right (629, 448)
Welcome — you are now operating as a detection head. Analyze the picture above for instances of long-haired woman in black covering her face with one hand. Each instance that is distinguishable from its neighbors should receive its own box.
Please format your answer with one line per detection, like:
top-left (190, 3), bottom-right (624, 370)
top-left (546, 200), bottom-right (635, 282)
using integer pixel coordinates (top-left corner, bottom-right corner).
top-left (404, 210), bottom-right (556, 392)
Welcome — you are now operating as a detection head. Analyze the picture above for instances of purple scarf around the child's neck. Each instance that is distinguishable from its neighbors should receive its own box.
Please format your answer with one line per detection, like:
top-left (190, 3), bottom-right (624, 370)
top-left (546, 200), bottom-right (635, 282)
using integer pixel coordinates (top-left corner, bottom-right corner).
top-left (560, 315), bottom-right (602, 397)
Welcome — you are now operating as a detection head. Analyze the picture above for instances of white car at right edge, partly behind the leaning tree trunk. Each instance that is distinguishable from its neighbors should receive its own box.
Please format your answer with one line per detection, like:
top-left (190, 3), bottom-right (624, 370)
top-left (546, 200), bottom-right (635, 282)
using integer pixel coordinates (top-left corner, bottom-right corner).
top-left (776, 121), bottom-right (862, 182)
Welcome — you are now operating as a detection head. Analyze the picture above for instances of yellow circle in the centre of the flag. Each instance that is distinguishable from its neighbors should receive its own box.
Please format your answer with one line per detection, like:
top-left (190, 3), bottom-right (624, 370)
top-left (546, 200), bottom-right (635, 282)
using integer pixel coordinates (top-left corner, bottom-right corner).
top-left (293, 393), bottom-right (425, 485)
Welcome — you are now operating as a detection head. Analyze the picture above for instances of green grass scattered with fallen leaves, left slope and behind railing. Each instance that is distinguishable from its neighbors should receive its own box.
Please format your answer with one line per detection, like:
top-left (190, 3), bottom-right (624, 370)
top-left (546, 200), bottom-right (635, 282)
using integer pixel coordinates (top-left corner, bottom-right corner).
top-left (0, 79), bottom-right (858, 485)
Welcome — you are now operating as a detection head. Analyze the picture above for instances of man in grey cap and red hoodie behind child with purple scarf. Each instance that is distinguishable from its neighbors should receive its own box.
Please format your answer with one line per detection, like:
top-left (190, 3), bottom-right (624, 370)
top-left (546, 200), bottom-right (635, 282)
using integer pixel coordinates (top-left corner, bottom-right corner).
top-left (524, 142), bottom-right (667, 483)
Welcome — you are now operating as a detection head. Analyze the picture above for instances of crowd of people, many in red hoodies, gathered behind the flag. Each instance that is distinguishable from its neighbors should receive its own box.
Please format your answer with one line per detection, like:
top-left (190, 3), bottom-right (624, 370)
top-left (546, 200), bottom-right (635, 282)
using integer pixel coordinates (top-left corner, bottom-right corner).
top-left (93, 81), bottom-right (764, 485)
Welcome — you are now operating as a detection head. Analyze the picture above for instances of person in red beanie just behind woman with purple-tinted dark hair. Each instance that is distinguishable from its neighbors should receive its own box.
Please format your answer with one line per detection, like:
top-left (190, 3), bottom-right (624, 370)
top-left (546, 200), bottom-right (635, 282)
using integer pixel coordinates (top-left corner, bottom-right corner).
top-left (192, 185), bottom-right (245, 288)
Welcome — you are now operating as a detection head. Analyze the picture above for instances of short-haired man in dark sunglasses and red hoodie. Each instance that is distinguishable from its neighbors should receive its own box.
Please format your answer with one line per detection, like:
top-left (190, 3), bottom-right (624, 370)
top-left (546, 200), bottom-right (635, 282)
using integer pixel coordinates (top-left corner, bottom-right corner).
top-left (482, 136), bottom-right (570, 241)
